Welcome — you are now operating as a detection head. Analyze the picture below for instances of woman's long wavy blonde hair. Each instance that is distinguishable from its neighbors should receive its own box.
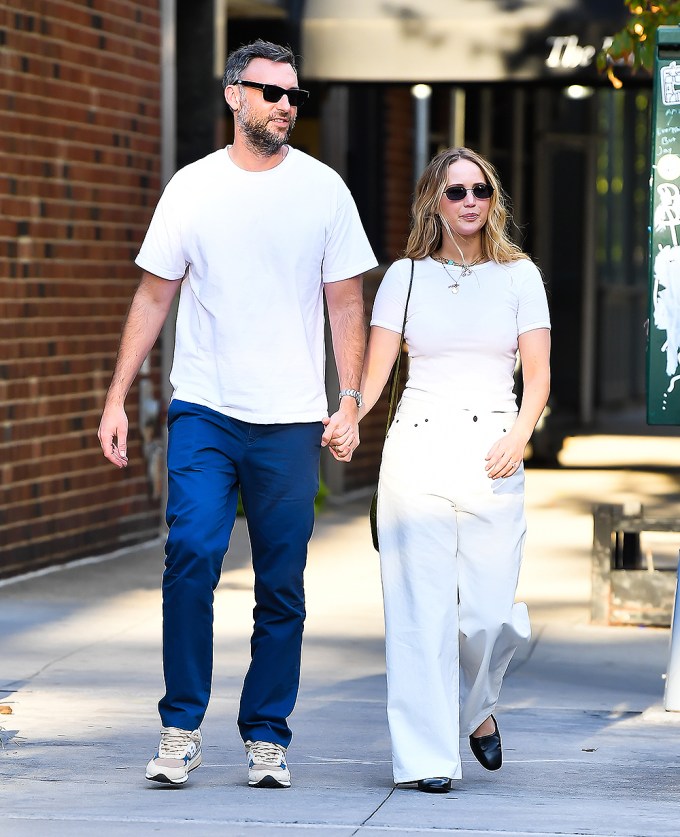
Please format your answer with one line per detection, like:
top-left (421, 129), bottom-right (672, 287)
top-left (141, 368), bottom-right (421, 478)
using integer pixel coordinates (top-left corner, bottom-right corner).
top-left (404, 148), bottom-right (529, 264)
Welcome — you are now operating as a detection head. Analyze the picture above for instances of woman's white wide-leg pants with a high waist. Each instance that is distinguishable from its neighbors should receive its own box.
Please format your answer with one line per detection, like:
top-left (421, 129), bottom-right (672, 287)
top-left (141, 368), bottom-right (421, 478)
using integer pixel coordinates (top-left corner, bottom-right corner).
top-left (378, 399), bottom-right (531, 783)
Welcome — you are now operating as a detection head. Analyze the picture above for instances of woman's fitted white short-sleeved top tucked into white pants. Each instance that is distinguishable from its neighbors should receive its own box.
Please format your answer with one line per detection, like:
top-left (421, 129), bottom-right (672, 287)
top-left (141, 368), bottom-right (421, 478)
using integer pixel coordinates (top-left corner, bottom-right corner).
top-left (371, 256), bottom-right (550, 412)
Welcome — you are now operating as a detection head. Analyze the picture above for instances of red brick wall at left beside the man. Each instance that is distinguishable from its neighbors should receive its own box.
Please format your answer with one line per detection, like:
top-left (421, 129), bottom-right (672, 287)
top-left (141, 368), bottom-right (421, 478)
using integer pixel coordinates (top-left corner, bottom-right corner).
top-left (0, 0), bottom-right (160, 576)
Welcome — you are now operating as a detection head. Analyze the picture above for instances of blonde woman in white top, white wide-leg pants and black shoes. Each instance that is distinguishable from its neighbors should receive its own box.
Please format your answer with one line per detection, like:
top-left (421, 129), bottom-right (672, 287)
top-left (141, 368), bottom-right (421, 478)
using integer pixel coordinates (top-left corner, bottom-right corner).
top-left (360, 148), bottom-right (550, 792)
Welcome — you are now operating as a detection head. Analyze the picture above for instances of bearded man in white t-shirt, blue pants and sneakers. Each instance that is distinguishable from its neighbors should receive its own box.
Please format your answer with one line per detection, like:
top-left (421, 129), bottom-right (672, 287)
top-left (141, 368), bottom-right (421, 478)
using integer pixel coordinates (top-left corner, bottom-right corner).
top-left (99, 41), bottom-right (376, 787)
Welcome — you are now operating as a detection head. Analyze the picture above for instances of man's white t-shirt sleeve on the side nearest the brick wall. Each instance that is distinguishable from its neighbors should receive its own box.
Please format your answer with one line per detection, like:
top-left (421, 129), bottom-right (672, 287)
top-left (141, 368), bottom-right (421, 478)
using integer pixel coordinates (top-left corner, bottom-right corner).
top-left (135, 175), bottom-right (187, 279)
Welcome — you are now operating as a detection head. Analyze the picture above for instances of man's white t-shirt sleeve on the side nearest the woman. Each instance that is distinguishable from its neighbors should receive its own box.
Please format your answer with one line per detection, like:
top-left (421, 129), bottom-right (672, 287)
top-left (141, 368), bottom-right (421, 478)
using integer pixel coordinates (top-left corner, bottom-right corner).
top-left (323, 177), bottom-right (378, 282)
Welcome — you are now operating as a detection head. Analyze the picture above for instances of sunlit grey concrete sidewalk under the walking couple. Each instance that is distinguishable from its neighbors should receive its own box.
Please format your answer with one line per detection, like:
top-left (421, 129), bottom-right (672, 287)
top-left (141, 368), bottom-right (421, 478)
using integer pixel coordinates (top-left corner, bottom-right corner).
top-left (0, 437), bottom-right (680, 837)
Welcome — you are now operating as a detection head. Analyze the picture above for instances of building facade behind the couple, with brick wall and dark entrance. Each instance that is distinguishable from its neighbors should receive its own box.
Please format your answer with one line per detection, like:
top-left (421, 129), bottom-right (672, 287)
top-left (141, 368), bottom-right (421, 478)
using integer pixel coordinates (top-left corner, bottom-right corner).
top-left (0, 0), bottom-right (651, 576)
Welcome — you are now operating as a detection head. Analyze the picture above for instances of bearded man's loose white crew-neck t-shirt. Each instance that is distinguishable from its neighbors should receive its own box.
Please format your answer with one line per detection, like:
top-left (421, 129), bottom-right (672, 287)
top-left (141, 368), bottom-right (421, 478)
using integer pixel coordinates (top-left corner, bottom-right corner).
top-left (136, 147), bottom-right (376, 424)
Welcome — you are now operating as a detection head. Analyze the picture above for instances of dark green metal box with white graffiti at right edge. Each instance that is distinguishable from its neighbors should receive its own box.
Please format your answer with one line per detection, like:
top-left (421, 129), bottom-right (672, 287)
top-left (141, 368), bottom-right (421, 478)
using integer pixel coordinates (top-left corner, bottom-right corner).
top-left (647, 26), bottom-right (680, 425)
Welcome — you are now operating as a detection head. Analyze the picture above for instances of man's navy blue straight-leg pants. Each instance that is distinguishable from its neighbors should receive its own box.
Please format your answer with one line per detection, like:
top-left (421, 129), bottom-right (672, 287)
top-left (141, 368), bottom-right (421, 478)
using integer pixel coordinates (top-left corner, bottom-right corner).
top-left (159, 401), bottom-right (323, 747)
